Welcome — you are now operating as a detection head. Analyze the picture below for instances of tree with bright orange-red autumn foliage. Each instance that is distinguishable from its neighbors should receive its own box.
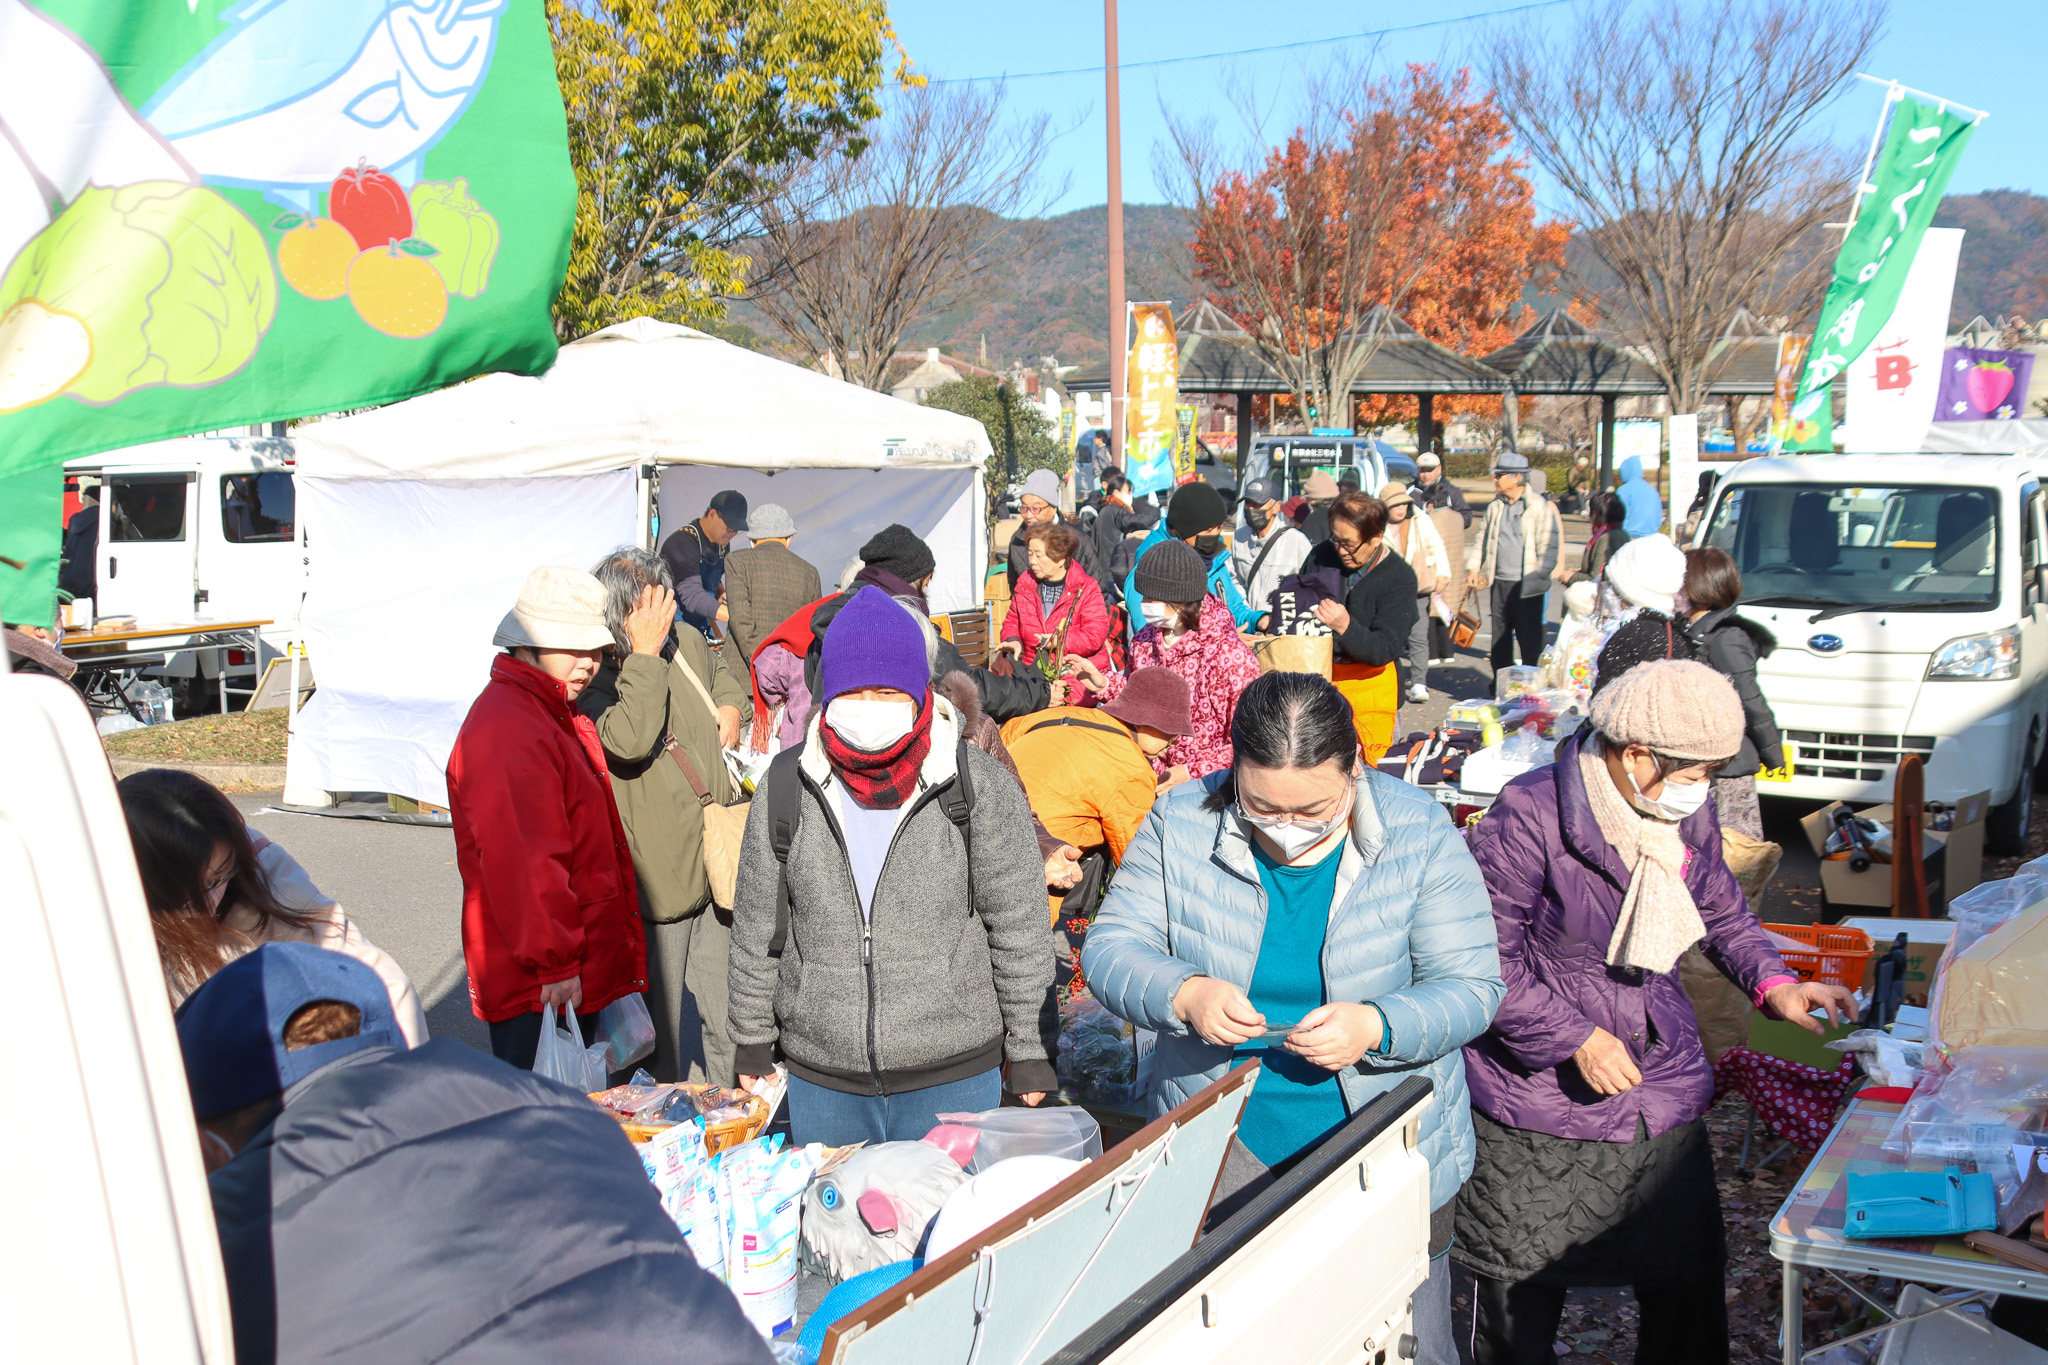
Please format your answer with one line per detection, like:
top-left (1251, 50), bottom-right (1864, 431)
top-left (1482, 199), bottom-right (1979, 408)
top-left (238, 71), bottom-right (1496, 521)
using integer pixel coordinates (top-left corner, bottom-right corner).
top-left (1174, 65), bottom-right (1571, 424)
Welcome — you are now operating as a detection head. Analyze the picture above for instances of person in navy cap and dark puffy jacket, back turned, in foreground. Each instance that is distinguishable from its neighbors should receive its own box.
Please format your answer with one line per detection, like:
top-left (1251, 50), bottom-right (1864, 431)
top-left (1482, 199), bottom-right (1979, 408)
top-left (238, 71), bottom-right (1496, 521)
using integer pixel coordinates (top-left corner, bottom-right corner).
top-left (178, 943), bottom-right (770, 1365)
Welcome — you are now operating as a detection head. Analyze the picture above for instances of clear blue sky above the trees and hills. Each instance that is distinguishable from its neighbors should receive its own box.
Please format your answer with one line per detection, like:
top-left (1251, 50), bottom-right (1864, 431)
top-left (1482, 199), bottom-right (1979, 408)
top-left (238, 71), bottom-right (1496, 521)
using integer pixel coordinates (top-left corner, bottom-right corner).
top-left (891, 0), bottom-right (2048, 213)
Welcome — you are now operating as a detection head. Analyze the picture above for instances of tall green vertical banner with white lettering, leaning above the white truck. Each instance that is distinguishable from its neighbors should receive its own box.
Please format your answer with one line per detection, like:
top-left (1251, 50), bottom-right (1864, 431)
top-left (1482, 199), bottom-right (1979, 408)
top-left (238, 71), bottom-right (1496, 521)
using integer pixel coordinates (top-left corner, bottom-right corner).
top-left (1786, 98), bottom-right (1976, 450)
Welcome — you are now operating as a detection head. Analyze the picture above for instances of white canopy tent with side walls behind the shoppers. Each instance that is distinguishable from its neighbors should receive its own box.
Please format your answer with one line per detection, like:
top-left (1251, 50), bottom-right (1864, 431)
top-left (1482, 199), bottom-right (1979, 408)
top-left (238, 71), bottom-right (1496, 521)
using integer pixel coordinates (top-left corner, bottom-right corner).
top-left (291, 319), bottom-right (989, 804)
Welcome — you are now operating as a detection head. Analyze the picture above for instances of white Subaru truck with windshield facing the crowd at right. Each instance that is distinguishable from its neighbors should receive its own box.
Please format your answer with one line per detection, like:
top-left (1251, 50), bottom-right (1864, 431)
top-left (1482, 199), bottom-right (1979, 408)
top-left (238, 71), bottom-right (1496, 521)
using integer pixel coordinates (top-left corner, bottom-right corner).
top-left (1698, 454), bottom-right (2048, 853)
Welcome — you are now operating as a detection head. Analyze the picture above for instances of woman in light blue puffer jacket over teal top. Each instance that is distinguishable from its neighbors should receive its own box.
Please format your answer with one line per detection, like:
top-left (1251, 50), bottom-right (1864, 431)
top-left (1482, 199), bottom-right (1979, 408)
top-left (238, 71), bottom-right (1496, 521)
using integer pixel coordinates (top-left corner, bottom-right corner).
top-left (1081, 673), bottom-right (1503, 1365)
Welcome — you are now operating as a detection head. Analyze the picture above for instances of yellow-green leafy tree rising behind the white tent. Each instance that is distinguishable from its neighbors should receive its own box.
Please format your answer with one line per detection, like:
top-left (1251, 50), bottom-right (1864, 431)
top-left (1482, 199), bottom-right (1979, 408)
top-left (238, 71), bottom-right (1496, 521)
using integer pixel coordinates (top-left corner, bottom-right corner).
top-left (547, 0), bottom-right (920, 338)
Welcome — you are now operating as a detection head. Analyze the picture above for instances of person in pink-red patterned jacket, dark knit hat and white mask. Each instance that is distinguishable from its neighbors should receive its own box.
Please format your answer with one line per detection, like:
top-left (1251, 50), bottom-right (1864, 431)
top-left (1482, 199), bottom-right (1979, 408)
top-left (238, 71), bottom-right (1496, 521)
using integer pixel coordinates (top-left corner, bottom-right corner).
top-left (1063, 540), bottom-right (1260, 788)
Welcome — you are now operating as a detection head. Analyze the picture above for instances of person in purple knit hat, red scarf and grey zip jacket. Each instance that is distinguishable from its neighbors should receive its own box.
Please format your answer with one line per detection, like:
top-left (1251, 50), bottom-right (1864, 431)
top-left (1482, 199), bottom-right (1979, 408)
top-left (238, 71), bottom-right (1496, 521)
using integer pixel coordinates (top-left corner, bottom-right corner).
top-left (727, 585), bottom-right (1057, 1146)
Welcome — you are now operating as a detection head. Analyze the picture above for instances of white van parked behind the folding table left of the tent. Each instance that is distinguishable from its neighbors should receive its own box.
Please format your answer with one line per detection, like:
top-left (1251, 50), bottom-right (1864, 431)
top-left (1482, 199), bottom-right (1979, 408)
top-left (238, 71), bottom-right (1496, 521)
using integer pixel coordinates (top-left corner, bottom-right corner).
top-left (63, 436), bottom-right (305, 704)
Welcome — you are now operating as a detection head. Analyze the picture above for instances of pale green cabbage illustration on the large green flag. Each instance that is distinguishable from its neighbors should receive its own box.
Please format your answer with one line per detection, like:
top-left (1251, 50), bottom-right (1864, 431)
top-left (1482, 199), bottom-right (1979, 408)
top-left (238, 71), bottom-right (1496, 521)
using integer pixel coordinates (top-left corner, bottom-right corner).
top-left (0, 180), bottom-right (276, 413)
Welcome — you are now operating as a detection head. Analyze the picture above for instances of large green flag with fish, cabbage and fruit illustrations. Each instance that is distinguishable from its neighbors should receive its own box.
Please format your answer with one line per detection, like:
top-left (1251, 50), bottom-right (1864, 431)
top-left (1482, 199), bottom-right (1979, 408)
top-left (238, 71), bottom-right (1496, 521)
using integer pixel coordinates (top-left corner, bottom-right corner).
top-left (0, 0), bottom-right (575, 489)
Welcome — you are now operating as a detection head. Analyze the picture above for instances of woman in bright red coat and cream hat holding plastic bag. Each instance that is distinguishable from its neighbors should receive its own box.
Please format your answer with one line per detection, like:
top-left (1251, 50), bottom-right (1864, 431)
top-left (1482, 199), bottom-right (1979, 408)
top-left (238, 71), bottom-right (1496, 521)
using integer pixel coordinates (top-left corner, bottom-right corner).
top-left (449, 565), bottom-right (647, 1070)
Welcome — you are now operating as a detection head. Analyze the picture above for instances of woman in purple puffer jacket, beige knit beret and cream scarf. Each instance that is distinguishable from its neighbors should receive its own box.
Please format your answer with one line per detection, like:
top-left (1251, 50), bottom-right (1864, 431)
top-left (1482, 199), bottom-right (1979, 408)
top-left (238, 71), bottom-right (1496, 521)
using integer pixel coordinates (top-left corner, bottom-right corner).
top-left (1452, 659), bottom-right (1853, 1365)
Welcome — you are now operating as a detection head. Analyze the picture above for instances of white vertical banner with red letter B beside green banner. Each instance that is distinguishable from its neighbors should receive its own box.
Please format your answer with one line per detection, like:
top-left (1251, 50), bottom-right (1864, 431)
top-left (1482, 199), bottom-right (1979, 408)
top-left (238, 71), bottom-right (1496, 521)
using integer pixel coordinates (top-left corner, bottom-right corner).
top-left (1841, 227), bottom-right (1962, 454)
